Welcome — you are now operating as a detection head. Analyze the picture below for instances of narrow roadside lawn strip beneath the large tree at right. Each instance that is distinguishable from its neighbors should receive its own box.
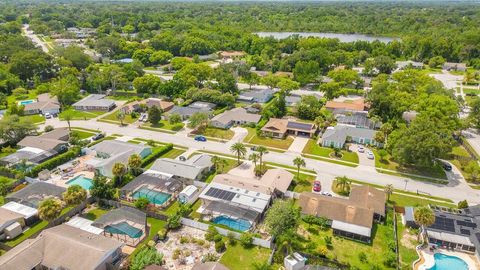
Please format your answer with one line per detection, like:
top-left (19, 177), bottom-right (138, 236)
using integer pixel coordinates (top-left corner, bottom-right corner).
top-left (372, 149), bottom-right (447, 179)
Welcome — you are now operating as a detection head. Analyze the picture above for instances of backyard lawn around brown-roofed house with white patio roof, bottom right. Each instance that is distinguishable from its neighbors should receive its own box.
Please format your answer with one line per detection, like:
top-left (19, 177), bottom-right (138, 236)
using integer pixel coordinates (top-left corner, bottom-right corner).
top-left (299, 212), bottom-right (395, 269)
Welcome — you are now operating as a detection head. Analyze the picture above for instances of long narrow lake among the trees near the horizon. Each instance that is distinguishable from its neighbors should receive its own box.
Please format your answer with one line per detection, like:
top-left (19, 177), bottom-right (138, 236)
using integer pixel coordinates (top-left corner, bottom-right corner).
top-left (255, 32), bottom-right (398, 43)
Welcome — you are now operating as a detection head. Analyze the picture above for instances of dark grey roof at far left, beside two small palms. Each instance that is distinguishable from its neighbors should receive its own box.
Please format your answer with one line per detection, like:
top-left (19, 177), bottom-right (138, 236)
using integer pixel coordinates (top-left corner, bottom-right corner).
top-left (5, 182), bottom-right (67, 209)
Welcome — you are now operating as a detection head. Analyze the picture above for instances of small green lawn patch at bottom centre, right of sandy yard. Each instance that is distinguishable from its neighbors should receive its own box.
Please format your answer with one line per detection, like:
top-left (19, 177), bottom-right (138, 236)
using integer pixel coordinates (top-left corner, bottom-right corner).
top-left (220, 241), bottom-right (271, 270)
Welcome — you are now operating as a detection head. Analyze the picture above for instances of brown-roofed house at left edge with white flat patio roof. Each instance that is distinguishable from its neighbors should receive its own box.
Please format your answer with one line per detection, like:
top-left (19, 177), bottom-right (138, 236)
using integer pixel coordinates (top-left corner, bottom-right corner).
top-left (0, 128), bottom-right (70, 167)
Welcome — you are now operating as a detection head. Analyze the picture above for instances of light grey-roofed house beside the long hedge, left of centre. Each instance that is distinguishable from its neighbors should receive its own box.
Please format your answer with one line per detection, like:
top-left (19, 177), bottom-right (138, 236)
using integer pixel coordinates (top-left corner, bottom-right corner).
top-left (85, 140), bottom-right (152, 178)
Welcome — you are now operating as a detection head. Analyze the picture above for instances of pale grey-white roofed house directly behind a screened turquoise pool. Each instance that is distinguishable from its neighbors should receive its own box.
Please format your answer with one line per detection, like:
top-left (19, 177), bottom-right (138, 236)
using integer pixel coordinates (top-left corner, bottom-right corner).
top-left (149, 154), bottom-right (213, 185)
